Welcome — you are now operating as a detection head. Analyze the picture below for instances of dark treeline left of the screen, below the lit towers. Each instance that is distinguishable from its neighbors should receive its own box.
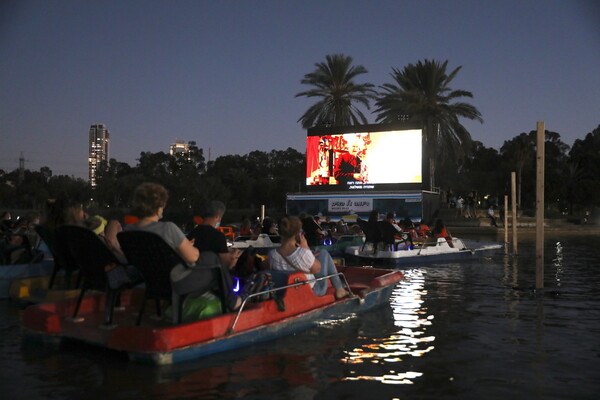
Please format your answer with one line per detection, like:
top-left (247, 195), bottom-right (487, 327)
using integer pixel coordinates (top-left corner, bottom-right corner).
top-left (0, 142), bottom-right (305, 221)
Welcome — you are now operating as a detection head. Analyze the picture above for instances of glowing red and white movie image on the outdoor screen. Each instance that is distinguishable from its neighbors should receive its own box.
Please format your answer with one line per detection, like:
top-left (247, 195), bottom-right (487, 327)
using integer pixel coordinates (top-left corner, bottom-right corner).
top-left (306, 129), bottom-right (422, 190)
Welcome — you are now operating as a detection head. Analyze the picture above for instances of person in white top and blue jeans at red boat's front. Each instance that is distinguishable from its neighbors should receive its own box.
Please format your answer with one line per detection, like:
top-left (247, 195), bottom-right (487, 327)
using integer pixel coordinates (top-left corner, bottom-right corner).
top-left (269, 217), bottom-right (348, 299)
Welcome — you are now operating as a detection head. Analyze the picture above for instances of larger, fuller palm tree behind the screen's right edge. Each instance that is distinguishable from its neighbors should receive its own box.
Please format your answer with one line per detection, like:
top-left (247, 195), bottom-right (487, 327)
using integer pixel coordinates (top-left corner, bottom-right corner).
top-left (375, 59), bottom-right (483, 186)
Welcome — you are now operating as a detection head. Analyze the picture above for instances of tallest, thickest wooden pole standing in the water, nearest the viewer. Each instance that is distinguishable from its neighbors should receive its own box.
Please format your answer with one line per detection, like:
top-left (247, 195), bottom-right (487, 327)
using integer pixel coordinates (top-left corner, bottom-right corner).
top-left (535, 121), bottom-right (545, 289)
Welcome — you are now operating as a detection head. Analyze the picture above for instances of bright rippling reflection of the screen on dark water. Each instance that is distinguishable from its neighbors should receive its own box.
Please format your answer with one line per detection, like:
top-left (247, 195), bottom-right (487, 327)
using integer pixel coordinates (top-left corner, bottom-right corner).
top-left (342, 269), bottom-right (435, 384)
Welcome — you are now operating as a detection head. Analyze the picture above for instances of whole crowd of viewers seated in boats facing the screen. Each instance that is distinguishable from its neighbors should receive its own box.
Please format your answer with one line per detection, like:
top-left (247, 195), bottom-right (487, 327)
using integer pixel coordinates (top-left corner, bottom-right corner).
top-left (0, 183), bottom-right (464, 324)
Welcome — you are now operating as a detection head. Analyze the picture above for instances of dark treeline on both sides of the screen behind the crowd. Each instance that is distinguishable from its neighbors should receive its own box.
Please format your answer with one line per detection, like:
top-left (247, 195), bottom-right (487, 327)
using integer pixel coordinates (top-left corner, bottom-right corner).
top-left (0, 126), bottom-right (600, 221)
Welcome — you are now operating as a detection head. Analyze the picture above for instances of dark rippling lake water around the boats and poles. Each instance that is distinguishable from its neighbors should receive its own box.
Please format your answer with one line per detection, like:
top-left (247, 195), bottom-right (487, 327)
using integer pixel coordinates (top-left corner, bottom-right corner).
top-left (0, 233), bottom-right (600, 400)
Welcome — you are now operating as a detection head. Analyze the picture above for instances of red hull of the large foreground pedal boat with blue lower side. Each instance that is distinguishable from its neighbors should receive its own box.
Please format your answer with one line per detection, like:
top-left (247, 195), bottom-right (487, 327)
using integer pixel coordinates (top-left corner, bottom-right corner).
top-left (23, 267), bottom-right (402, 365)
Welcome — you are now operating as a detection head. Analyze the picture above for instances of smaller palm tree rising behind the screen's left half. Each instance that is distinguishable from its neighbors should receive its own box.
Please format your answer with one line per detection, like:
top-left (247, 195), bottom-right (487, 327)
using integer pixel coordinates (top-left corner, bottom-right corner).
top-left (295, 54), bottom-right (377, 128)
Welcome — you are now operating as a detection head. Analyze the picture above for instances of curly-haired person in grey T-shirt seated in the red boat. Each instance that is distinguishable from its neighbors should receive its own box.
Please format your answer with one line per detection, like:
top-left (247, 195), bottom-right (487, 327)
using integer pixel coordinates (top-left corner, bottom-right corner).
top-left (125, 183), bottom-right (242, 310)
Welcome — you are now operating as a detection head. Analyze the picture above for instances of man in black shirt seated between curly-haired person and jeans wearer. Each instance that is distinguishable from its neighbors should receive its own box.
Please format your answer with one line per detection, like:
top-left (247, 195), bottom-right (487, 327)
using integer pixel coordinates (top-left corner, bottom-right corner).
top-left (188, 200), bottom-right (242, 268)
